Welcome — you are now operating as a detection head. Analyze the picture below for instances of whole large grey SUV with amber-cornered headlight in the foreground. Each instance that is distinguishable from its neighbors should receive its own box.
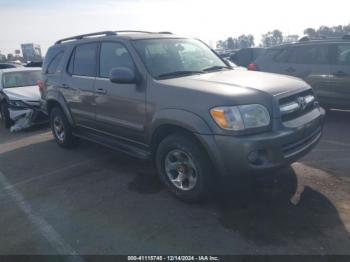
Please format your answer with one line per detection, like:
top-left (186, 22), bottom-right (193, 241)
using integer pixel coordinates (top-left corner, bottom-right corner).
top-left (40, 31), bottom-right (324, 201)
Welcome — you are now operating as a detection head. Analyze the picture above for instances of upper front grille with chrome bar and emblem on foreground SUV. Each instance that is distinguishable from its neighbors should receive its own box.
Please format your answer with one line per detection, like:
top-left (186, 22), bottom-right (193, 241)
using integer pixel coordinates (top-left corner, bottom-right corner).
top-left (279, 90), bottom-right (316, 122)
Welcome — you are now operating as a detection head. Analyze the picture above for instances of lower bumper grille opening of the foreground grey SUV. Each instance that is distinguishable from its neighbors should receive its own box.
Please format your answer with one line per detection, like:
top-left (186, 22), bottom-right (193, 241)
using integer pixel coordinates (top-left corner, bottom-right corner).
top-left (282, 128), bottom-right (322, 158)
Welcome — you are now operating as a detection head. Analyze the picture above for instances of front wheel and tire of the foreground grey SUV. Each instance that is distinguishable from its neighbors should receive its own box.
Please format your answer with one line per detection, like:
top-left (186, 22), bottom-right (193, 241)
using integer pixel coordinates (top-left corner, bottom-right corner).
top-left (155, 134), bottom-right (214, 202)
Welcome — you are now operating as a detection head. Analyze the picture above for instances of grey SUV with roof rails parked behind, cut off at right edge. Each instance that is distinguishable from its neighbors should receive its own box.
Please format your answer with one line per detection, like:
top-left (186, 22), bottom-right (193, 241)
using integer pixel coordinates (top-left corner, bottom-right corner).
top-left (248, 36), bottom-right (350, 109)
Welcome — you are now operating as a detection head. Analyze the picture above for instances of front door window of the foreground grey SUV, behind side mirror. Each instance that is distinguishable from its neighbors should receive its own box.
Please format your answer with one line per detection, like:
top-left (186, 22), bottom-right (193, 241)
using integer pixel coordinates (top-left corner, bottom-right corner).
top-left (99, 42), bottom-right (134, 78)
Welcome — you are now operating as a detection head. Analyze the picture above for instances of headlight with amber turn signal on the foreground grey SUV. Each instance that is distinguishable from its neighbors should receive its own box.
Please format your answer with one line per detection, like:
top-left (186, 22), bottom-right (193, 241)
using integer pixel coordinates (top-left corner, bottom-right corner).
top-left (210, 104), bottom-right (270, 131)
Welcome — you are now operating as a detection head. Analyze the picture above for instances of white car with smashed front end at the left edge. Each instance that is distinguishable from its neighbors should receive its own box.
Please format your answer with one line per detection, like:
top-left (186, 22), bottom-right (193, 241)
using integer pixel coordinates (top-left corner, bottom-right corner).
top-left (0, 68), bottom-right (48, 132)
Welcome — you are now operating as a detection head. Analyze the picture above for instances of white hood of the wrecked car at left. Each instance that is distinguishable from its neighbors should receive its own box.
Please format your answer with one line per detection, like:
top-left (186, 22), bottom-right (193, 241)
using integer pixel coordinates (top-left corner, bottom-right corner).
top-left (2, 86), bottom-right (40, 101)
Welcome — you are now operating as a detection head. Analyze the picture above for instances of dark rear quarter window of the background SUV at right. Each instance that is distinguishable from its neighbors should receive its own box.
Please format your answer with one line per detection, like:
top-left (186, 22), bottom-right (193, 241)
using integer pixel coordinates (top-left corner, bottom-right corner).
top-left (288, 45), bottom-right (329, 65)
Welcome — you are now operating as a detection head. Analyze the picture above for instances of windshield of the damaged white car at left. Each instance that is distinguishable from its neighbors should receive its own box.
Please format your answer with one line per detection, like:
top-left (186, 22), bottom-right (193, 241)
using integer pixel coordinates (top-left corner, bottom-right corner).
top-left (2, 70), bottom-right (40, 88)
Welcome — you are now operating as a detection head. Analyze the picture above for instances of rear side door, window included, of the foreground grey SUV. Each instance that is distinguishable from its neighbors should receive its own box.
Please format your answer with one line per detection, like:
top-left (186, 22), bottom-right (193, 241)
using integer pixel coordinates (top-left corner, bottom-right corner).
top-left (61, 43), bottom-right (98, 127)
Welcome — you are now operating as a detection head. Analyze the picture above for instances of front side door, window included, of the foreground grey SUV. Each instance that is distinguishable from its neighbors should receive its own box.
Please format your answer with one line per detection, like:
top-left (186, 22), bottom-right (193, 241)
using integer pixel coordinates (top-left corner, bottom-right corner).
top-left (95, 42), bottom-right (146, 142)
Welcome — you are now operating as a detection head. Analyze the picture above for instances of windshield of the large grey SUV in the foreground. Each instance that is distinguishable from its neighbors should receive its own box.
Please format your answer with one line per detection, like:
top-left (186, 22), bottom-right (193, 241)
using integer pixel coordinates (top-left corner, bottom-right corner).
top-left (134, 38), bottom-right (228, 79)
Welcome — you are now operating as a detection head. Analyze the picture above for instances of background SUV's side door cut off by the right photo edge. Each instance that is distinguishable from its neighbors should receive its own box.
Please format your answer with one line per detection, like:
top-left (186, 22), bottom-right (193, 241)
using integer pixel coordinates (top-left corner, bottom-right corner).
top-left (330, 43), bottom-right (350, 108)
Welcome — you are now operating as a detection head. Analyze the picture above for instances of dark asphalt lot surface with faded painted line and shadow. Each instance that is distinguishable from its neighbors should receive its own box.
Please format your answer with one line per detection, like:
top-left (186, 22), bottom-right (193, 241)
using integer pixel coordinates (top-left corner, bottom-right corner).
top-left (0, 111), bottom-right (350, 255)
